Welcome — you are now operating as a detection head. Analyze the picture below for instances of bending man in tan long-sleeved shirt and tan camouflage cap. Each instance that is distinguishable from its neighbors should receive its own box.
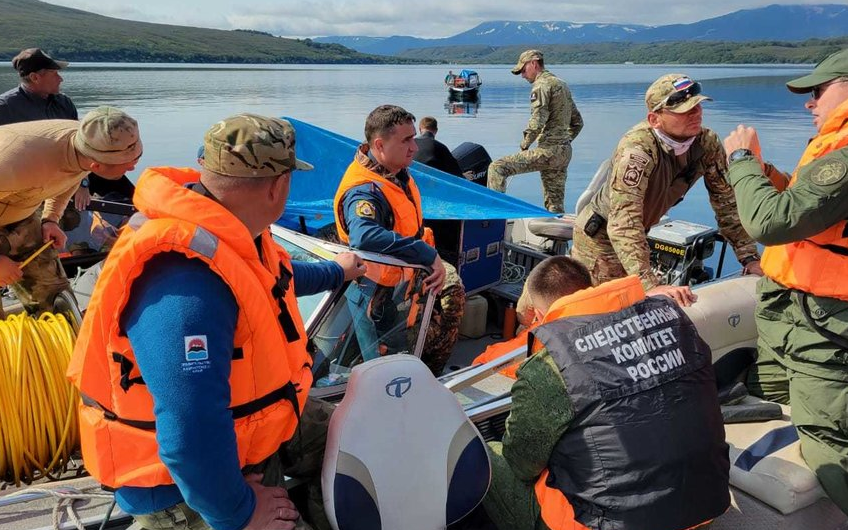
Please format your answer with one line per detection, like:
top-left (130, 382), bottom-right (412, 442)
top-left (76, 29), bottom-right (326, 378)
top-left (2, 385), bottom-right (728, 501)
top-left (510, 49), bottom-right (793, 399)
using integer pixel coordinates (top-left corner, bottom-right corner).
top-left (0, 107), bottom-right (142, 312)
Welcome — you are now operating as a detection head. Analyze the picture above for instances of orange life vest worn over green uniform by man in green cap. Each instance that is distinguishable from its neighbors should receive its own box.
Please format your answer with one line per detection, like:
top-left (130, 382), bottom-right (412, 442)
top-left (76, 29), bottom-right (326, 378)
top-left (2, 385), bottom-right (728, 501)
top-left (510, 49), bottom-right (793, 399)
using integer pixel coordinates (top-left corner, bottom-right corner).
top-left (760, 98), bottom-right (848, 300)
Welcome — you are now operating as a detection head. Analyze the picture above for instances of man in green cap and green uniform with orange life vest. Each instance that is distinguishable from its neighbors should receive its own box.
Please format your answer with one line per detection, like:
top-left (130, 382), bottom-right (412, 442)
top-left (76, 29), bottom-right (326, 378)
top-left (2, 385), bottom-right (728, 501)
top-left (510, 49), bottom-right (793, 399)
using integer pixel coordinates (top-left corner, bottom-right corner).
top-left (724, 49), bottom-right (848, 514)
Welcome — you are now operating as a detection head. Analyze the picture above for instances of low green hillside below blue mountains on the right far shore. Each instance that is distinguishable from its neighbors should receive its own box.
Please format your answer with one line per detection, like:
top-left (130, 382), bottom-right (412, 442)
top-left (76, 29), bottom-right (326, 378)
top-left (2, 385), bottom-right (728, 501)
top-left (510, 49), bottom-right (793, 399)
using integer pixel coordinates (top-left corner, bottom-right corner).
top-left (400, 37), bottom-right (848, 64)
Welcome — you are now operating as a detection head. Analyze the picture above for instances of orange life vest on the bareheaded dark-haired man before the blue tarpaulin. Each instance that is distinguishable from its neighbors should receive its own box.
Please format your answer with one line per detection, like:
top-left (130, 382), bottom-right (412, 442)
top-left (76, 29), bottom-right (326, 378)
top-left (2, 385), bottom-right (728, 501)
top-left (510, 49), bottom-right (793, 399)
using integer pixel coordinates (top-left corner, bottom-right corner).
top-left (333, 160), bottom-right (435, 246)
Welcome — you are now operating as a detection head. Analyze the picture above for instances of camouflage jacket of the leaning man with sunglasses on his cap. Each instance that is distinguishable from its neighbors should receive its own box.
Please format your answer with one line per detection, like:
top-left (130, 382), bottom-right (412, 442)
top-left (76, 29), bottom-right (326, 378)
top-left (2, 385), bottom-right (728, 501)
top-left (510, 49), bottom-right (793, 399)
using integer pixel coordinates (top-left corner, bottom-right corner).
top-left (590, 121), bottom-right (757, 290)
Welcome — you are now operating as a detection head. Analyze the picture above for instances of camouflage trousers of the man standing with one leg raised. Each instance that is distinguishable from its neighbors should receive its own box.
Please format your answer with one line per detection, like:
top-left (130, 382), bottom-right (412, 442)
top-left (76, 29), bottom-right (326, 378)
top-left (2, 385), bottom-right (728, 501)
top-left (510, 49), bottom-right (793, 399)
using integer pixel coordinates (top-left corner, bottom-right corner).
top-left (488, 143), bottom-right (571, 213)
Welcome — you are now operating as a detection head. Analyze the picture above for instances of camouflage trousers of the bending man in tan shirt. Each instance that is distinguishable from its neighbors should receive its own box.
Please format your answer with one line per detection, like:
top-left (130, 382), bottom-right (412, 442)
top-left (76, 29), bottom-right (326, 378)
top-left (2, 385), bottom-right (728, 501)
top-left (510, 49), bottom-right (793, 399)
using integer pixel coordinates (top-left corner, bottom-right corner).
top-left (0, 210), bottom-right (70, 318)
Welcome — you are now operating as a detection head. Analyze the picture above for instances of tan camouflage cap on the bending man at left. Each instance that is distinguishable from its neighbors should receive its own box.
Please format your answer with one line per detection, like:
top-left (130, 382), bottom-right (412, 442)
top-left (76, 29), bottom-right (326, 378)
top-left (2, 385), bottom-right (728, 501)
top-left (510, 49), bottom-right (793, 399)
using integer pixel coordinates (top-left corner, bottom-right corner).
top-left (74, 107), bottom-right (142, 165)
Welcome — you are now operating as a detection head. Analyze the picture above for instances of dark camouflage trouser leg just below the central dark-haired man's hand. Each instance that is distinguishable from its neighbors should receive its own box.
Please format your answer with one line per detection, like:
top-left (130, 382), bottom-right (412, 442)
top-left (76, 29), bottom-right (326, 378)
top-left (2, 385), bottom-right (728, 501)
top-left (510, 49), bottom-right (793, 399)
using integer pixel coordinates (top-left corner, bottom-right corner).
top-left (421, 262), bottom-right (465, 376)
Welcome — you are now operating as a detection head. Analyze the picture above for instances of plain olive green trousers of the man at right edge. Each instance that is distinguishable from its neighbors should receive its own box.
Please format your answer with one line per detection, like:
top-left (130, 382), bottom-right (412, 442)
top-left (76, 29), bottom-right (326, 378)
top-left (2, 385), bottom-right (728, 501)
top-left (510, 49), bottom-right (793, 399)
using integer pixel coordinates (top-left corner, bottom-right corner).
top-left (748, 278), bottom-right (848, 514)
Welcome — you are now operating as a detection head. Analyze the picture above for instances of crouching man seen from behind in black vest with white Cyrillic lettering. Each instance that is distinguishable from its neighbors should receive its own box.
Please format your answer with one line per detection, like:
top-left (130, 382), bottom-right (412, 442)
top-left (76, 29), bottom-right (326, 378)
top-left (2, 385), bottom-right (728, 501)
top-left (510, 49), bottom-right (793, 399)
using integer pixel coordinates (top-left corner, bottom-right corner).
top-left (484, 256), bottom-right (730, 530)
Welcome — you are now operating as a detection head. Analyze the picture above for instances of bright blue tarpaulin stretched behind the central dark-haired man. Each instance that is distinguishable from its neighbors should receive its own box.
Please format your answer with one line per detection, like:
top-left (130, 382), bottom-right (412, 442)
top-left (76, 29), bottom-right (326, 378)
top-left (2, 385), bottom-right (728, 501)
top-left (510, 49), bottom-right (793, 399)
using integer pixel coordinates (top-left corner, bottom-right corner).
top-left (278, 118), bottom-right (553, 233)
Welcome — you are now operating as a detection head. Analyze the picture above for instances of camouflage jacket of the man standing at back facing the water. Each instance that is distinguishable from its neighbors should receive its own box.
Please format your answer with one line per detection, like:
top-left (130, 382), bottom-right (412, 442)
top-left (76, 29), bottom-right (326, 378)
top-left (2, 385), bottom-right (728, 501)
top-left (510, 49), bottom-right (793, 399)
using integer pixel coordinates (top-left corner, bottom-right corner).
top-left (521, 70), bottom-right (583, 149)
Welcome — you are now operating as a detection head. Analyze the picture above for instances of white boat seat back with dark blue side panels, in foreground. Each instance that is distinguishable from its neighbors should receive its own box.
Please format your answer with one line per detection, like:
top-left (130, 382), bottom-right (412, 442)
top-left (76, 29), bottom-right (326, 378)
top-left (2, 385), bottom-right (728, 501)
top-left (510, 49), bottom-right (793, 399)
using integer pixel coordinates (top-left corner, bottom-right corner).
top-left (321, 354), bottom-right (491, 530)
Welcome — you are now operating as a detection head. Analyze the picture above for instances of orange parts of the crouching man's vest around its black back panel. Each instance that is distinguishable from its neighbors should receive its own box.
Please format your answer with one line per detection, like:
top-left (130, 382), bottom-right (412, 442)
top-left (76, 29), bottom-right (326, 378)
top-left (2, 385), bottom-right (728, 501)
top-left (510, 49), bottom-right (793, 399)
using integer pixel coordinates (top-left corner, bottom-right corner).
top-left (534, 276), bottom-right (645, 530)
